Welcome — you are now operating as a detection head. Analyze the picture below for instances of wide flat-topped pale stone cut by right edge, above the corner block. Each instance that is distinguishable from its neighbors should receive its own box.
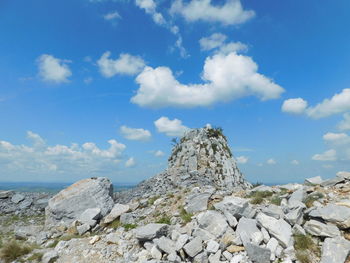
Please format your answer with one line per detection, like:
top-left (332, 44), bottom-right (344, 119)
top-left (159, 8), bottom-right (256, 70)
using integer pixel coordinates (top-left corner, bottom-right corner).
top-left (309, 204), bottom-right (350, 228)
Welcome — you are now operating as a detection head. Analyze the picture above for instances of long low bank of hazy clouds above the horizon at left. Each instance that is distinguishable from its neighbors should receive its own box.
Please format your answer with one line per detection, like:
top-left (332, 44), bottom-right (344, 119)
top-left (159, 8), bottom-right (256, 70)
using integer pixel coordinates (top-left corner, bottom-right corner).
top-left (0, 131), bottom-right (126, 177)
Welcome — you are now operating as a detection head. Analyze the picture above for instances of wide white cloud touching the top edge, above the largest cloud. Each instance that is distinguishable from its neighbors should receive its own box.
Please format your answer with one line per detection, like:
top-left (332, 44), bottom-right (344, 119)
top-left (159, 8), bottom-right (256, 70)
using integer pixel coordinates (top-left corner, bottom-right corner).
top-left (170, 0), bottom-right (255, 25)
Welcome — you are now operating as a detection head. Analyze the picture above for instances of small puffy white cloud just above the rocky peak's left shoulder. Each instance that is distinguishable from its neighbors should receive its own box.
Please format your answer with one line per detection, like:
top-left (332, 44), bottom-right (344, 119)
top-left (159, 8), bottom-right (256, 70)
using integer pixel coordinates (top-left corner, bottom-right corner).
top-left (154, 117), bottom-right (189, 137)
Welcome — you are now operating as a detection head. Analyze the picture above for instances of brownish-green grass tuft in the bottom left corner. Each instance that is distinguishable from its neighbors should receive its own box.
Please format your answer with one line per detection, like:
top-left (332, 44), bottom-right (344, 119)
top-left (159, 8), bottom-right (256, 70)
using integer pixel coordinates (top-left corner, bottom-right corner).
top-left (0, 240), bottom-right (33, 263)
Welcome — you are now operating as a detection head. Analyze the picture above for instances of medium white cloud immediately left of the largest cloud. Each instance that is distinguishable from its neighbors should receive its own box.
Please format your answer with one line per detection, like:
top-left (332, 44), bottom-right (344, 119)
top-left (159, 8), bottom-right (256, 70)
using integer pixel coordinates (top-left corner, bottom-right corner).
top-left (97, 51), bottom-right (145, 78)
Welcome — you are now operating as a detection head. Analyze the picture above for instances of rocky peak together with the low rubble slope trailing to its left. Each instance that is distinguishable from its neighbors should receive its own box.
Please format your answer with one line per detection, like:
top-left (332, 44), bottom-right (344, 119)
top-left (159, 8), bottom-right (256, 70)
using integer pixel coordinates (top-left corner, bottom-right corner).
top-left (115, 126), bottom-right (251, 203)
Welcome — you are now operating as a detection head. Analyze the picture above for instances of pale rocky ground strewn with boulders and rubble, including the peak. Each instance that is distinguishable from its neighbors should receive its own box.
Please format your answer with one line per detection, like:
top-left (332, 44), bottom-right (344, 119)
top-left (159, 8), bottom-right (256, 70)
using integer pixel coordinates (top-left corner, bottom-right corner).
top-left (0, 128), bottom-right (350, 263)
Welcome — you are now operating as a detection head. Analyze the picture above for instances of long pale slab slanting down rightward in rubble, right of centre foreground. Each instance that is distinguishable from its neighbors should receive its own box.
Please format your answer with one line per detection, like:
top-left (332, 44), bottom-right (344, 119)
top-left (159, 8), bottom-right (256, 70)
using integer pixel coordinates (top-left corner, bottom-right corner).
top-left (256, 213), bottom-right (293, 247)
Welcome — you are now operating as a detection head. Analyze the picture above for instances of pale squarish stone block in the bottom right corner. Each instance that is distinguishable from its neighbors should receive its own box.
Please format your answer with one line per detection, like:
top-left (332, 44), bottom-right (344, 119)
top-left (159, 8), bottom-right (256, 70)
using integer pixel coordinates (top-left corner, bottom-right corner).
top-left (320, 237), bottom-right (350, 263)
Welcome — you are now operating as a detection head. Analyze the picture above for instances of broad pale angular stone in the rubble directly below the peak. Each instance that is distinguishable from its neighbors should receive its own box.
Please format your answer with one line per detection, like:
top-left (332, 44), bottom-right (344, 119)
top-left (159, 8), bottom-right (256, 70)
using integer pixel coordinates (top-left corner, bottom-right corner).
top-left (197, 210), bottom-right (228, 237)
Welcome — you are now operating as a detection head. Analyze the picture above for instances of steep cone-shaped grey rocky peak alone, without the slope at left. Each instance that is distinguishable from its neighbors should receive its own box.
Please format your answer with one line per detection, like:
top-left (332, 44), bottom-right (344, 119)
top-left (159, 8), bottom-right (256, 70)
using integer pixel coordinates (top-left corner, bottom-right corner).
top-left (168, 125), bottom-right (250, 189)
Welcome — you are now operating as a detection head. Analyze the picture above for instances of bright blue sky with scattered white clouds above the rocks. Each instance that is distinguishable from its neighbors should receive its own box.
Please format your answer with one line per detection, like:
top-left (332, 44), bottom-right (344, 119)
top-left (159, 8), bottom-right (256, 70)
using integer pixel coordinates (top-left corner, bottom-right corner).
top-left (0, 0), bottom-right (350, 183)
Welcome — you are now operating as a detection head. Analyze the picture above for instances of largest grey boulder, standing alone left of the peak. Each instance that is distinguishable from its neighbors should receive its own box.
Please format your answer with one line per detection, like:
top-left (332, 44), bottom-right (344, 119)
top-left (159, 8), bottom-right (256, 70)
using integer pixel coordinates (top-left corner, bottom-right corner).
top-left (45, 177), bottom-right (114, 226)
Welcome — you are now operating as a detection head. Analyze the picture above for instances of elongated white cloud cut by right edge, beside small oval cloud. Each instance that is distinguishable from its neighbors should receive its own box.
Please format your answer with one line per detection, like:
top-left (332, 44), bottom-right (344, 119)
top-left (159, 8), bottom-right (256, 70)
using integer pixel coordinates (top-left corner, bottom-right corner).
top-left (307, 89), bottom-right (350, 119)
